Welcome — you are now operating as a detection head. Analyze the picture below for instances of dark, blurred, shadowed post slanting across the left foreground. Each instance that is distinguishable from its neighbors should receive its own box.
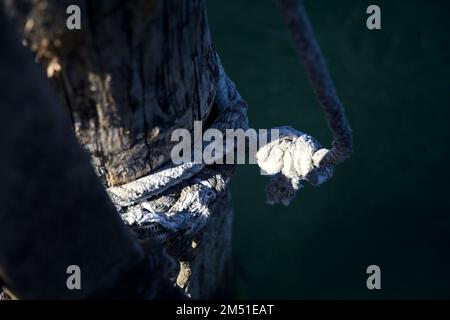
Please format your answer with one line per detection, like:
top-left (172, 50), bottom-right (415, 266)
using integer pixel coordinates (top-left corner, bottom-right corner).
top-left (0, 10), bottom-right (167, 299)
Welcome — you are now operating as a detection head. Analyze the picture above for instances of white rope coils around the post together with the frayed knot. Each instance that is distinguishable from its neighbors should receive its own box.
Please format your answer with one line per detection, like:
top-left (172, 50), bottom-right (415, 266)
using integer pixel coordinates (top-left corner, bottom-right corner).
top-left (108, 53), bottom-right (333, 241)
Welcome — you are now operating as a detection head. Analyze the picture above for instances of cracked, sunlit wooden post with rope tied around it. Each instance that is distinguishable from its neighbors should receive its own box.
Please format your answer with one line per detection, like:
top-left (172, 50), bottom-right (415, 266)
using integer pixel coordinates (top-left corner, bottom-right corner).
top-left (5, 0), bottom-right (232, 298)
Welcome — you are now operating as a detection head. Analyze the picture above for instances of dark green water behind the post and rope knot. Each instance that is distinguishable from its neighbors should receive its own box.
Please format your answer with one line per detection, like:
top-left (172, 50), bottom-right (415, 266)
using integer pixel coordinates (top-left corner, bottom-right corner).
top-left (206, 0), bottom-right (450, 298)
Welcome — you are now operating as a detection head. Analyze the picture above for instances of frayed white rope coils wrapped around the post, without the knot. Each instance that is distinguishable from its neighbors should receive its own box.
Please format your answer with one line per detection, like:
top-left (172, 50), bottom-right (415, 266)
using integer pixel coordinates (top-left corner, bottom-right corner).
top-left (107, 56), bottom-right (248, 240)
